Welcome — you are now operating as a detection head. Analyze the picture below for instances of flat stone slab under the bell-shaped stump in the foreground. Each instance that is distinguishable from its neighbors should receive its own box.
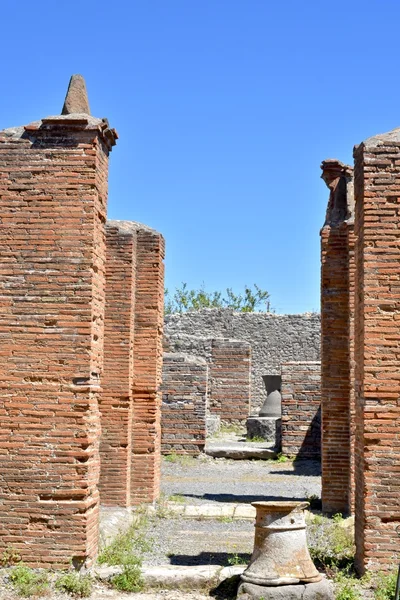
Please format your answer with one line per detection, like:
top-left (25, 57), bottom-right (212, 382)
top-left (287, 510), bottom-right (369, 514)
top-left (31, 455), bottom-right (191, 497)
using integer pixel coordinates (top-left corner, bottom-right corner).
top-left (237, 579), bottom-right (334, 600)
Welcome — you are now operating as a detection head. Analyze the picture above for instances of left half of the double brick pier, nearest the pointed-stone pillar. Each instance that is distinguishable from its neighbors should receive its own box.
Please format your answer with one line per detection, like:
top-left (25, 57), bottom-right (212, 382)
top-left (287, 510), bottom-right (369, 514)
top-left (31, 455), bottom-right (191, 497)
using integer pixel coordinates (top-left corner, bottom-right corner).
top-left (99, 221), bottom-right (136, 506)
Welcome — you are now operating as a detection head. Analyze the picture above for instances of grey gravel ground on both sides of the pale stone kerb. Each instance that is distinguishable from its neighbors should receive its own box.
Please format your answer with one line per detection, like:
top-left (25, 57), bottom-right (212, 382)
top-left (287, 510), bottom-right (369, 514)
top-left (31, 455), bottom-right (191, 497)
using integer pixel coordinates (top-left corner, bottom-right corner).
top-left (141, 456), bottom-right (321, 566)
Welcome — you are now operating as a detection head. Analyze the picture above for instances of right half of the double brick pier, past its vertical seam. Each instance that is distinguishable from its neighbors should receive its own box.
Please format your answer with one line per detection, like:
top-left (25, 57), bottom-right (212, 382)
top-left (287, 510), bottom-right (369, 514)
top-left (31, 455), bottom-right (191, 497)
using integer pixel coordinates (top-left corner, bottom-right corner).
top-left (131, 225), bottom-right (165, 504)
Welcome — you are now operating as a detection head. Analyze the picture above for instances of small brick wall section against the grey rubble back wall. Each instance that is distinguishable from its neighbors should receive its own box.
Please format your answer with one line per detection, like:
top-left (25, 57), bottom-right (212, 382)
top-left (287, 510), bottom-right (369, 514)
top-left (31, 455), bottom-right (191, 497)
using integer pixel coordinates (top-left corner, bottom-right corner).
top-left (209, 339), bottom-right (251, 423)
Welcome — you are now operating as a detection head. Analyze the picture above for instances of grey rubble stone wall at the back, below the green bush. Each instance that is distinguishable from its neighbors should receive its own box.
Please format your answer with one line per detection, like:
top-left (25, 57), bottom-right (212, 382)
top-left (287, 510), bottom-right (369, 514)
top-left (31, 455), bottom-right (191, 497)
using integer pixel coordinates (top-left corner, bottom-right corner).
top-left (165, 309), bottom-right (320, 414)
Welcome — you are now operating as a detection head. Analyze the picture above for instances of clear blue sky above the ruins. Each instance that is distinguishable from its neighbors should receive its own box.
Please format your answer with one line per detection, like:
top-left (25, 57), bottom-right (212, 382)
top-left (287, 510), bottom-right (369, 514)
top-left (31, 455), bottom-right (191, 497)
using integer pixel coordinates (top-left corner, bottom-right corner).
top-left (0, 0), bottom-right (400, 313)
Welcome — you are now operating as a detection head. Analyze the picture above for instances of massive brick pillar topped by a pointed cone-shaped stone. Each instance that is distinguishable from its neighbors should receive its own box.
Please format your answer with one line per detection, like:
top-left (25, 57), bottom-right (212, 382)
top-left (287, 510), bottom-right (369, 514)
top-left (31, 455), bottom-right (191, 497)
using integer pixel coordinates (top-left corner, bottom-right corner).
top-left (0, 77), bottom-right (116, 567)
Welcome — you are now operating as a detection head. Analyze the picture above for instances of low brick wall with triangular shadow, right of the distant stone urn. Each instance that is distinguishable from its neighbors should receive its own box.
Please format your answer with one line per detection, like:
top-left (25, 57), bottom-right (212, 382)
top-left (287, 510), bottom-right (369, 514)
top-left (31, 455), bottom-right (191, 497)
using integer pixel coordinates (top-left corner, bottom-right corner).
top-left (281, 362), bottom-right (321, 459)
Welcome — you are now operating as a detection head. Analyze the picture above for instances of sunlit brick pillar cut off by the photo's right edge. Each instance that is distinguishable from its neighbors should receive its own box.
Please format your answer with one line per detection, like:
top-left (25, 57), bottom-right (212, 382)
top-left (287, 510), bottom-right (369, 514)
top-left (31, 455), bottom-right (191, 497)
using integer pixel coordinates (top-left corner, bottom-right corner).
top-left (355, 135), bottom-right (400, 572)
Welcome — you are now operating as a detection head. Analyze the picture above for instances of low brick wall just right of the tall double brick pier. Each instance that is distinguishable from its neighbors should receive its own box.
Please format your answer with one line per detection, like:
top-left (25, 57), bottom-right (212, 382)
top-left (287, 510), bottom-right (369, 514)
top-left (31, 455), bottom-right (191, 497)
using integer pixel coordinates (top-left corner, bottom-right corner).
top-left (161, 353), bottom-right (208, 455)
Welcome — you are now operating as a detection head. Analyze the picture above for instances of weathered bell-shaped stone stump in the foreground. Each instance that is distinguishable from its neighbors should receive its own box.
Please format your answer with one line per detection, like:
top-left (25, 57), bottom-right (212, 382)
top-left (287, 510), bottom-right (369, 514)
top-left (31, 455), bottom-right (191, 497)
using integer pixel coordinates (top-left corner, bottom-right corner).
top-left (242, 501), bottom-right (321, 586)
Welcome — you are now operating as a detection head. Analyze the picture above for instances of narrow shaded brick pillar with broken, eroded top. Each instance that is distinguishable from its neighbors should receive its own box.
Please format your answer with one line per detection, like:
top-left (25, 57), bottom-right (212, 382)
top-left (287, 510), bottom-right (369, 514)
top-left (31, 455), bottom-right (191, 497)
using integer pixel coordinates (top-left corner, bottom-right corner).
top-left (321, 160), bottom-right (354, 514)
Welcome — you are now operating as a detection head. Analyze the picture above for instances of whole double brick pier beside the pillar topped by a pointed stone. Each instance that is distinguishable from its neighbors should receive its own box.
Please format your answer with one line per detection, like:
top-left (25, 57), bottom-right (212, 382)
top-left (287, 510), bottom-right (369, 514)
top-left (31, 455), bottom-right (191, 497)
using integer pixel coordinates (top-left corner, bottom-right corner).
top-left (100, 221), bottom-right (164, 506)
